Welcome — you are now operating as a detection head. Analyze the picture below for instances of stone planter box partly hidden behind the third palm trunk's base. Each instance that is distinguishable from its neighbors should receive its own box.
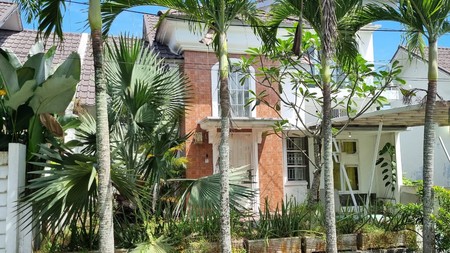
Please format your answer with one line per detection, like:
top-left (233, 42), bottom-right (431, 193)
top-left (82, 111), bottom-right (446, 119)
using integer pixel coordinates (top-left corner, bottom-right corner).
top-left (302, 234), bottom-right (358, 253)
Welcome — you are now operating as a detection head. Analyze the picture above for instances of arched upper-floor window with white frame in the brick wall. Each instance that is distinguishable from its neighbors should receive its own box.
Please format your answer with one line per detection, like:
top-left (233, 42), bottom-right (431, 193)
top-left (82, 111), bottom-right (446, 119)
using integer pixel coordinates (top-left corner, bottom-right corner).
top-left (211, 59), bottom-right (256, 118)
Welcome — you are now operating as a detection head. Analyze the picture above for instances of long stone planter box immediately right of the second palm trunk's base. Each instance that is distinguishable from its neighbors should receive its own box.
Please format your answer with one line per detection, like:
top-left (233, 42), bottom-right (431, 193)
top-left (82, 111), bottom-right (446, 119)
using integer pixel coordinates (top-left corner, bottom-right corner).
top-left (244, 237), bottom-right (302, 253)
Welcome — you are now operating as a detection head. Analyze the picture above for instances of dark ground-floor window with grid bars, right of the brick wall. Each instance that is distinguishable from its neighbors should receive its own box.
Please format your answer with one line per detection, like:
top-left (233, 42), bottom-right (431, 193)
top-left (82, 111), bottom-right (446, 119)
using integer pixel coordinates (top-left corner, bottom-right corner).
top-left (286, 137), bottom-right (309, 181)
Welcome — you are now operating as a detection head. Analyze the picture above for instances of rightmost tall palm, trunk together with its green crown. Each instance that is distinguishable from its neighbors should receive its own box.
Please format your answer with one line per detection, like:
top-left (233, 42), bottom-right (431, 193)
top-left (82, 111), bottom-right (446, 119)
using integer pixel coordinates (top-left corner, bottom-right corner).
top-left (362, 0), bottom-right (450, 252)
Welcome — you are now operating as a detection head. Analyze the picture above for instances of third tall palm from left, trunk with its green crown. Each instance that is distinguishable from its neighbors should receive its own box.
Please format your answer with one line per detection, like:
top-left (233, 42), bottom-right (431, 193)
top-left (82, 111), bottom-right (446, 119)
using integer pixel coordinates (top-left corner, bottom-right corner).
top-left (266, 0), bottom-right (361, 252)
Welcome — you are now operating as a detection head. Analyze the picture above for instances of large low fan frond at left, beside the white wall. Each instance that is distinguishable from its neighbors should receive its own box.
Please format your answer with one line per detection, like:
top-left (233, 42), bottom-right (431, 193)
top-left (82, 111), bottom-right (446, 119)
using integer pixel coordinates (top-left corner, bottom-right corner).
top-left (19, 144), bottom-right (137, 236)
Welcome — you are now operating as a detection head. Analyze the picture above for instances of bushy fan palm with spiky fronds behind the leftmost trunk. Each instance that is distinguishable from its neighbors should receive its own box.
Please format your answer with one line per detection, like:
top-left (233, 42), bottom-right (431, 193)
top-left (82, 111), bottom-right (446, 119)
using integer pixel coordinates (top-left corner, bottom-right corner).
top-left (23, 37), bottom-right (187, 249)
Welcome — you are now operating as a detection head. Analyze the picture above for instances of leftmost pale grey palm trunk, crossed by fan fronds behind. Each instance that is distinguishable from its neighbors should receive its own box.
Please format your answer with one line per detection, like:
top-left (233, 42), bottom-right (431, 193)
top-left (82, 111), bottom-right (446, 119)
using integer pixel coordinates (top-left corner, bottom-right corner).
top-left (89, 0), bottom-right (114, 253)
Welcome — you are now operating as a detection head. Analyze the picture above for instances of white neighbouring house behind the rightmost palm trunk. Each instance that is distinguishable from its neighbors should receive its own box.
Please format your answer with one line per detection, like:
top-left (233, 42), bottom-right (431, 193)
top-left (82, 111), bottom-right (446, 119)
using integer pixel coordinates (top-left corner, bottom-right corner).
top-left (391, 46), bottom-right (450, 187)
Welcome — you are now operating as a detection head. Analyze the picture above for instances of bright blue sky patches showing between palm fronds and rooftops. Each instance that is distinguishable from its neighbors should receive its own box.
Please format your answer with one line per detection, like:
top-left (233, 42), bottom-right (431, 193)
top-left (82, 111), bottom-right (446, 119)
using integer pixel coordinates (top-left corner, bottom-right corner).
top-left (24, 1), bottom-right (450, 65)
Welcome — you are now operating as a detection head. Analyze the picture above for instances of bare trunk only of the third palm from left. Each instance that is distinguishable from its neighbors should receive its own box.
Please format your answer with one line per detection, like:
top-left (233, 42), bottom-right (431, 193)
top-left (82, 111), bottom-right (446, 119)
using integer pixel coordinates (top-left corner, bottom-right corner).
top-left (320, 0), bottom-right (337, 253)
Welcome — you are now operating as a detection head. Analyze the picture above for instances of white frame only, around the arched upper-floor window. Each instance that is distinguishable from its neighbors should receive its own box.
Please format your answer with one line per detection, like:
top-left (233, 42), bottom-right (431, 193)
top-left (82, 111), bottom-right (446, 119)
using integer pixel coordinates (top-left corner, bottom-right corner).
top-left (211, 58), bottom-right (256, 118)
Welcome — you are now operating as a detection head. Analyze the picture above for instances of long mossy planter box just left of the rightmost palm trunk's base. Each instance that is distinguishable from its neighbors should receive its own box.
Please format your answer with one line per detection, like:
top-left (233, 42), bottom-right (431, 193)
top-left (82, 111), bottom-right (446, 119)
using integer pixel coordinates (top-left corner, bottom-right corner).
top-left (358, 230), bottom-right (416, 250)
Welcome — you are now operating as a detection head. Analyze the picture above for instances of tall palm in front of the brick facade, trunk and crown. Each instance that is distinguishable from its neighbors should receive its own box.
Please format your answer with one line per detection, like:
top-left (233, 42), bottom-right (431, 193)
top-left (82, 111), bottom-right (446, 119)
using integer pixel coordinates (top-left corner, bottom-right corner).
top-left (103, 0), bottom-right (259, 252)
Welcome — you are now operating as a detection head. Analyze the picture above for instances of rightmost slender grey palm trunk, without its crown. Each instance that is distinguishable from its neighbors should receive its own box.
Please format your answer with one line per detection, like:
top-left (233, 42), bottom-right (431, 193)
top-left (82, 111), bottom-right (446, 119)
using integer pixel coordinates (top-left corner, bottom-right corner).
top-left (423, 41), bottom-right (438, 252)
